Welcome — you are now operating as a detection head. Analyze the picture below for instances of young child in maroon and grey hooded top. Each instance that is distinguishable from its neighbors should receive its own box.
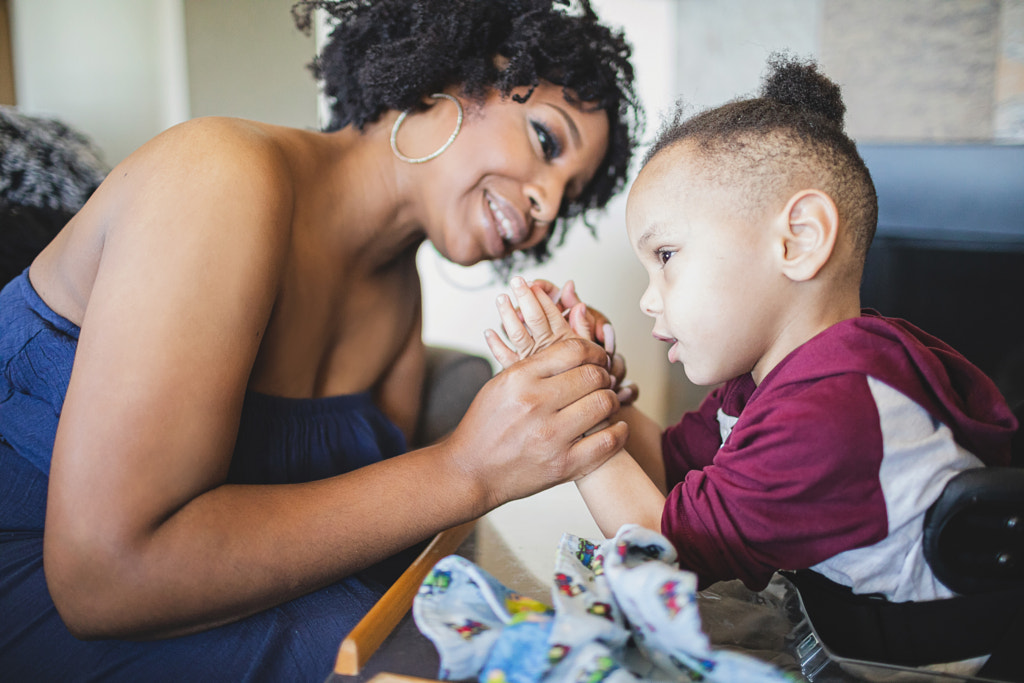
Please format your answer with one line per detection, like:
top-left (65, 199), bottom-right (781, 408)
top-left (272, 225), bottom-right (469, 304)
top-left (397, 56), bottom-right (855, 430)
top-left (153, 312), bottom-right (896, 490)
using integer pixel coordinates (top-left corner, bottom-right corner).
top-left (487, 55), bottom-right (1017, 667)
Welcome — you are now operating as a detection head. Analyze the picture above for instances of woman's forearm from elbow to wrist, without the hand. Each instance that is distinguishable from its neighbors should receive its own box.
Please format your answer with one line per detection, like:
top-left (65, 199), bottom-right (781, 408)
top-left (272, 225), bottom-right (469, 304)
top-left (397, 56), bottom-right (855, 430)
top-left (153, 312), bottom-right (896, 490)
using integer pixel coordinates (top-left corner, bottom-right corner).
top-left (44, 444), bottom-right (487, 638)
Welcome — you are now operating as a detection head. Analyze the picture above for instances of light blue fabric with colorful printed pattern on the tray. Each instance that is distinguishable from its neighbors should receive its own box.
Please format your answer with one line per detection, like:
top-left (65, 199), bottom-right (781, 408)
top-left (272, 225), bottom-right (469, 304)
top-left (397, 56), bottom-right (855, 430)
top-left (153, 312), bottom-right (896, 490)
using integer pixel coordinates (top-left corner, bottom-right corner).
top-left (413, 525), bottom-right (790, 683)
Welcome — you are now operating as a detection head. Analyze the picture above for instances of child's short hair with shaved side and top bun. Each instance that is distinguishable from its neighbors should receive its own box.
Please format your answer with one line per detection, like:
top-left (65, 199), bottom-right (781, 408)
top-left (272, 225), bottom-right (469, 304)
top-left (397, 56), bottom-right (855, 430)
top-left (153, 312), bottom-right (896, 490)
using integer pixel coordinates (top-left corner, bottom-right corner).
top-left (643, 53), bottom-right (878, 264)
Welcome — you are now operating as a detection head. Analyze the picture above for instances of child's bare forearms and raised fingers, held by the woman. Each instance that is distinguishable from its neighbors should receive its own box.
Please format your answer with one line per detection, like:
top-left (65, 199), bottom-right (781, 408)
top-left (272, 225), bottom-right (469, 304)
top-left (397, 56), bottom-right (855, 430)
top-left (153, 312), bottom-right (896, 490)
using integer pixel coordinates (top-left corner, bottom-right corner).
top-left (484, 278), bottom-right (665, 538)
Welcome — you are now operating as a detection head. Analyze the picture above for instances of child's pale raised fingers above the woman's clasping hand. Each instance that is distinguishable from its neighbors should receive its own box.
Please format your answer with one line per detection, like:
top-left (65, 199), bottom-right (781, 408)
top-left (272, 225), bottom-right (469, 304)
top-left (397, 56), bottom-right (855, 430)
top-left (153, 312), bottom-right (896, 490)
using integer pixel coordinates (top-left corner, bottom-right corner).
top-left (484, 276), bottom-right (594, 368)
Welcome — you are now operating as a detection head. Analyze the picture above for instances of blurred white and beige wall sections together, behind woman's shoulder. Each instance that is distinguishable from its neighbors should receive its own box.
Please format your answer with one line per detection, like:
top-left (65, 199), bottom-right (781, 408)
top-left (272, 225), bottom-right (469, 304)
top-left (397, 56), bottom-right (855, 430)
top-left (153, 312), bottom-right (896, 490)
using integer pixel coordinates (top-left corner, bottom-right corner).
top-left (10, 0), bottom-right (317, 166)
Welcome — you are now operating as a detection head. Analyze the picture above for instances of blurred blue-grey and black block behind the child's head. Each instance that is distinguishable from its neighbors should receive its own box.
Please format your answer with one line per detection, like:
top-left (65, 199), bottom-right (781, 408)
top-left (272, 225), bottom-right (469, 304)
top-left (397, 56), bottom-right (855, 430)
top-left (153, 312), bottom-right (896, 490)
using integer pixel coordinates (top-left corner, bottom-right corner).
top-left (859, 144), bottom-right (1024, 465)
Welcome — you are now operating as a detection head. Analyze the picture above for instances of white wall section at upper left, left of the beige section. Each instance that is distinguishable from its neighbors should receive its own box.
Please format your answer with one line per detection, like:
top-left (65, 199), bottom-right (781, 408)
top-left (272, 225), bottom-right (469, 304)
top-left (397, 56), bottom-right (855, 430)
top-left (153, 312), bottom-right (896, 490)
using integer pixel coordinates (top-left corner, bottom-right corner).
top-left (10, 0), bottom-right (188, 165)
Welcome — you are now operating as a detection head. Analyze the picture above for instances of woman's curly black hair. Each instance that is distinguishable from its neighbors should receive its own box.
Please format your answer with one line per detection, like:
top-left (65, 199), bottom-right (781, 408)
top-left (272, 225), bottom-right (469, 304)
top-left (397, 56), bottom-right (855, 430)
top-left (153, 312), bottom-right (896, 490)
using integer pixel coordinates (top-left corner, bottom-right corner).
top-left (292, 0), bottom-right (643, 269)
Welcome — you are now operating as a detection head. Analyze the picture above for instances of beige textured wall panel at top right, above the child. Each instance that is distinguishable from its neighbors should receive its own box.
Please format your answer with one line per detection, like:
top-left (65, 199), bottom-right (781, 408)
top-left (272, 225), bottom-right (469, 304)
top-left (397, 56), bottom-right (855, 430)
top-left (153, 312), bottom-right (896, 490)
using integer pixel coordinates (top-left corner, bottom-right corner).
top-left (821, 0), bottom-right (1002, 142)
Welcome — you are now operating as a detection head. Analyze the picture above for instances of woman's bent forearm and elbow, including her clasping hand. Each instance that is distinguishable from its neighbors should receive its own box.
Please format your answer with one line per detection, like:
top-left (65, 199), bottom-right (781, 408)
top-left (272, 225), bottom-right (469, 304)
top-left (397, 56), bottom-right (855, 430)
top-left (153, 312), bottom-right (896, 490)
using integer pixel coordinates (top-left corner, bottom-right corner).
top-left (43, 340), bottom-right (627, 638)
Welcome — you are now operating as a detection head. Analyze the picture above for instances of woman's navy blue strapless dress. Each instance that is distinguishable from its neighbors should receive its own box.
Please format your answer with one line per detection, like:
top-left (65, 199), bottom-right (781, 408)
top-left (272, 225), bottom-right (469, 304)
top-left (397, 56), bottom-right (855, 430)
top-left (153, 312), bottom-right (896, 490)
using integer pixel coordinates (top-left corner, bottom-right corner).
top-left (0, 270), bottom-right (406, 682)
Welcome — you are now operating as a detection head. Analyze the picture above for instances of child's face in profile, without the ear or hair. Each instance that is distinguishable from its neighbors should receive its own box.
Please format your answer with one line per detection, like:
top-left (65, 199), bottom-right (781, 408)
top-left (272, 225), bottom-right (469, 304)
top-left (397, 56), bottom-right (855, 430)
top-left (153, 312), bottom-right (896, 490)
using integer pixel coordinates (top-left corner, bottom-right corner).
top-left (626, 143), bottom-right (785, 385)
